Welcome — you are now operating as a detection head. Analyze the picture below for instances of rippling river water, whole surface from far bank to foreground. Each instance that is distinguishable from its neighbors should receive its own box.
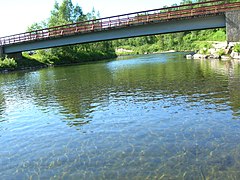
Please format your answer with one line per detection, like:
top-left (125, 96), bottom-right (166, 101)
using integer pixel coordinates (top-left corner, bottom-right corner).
top-left (0, 53), bottom-right (240, 180)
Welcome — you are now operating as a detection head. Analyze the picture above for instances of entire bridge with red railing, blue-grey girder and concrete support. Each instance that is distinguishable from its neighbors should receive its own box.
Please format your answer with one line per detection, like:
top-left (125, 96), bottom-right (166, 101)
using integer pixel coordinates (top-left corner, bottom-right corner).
top-left (0, 0), bottom-right (240, 57)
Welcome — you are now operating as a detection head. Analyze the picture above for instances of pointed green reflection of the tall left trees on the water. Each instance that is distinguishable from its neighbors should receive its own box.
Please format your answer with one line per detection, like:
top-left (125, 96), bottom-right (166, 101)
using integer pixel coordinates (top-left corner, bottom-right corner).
top-left (30, 64), bottom-right (114, 126)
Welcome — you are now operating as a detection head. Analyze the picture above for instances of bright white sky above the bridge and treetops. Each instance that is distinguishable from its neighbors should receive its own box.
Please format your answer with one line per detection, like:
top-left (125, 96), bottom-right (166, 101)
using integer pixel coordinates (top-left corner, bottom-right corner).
top-left (0, 0), bottom-right (181, 37)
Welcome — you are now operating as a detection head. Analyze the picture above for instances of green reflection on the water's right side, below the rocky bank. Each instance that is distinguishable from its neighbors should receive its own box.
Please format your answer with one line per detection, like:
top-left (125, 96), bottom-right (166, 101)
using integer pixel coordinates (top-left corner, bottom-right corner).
top-left (110, 57), bottom-right (240, 112)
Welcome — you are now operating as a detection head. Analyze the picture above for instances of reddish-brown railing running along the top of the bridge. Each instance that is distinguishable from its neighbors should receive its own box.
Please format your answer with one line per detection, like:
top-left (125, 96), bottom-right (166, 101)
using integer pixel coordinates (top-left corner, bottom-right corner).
top-left (0, 0), bottom-right (240, 46)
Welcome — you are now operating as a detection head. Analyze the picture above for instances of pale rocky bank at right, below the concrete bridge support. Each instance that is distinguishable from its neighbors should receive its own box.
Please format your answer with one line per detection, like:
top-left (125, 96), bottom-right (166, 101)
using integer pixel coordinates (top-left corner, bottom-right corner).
top-left (186, 42), bottom-right (240, 61)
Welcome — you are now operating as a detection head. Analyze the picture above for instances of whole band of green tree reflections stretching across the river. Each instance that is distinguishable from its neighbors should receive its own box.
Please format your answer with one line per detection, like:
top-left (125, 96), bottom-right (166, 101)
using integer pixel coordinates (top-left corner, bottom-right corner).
top-left (28, 55), bottom-right (240, 126)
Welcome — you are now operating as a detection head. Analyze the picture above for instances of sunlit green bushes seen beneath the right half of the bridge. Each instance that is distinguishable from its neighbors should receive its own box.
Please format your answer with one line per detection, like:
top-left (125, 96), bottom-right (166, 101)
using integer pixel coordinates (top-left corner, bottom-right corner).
top-left (113, 28), bottom-right (226, 55)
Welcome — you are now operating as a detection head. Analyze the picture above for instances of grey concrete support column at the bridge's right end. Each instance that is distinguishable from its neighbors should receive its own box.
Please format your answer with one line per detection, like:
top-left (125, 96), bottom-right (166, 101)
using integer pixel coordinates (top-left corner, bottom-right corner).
top-left (226, 10), bottom-right (240, 42)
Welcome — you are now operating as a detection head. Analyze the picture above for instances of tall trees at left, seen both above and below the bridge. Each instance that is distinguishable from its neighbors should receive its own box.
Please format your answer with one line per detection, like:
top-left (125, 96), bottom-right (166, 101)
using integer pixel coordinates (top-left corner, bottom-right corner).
top-left (25, 0), bottom-right (116, 65)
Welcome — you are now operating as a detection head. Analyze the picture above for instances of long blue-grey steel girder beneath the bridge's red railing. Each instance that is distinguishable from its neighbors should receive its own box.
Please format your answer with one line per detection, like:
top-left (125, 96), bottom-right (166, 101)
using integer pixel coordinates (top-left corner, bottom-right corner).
top-left (4, 14), bottom-right (226, 54)
